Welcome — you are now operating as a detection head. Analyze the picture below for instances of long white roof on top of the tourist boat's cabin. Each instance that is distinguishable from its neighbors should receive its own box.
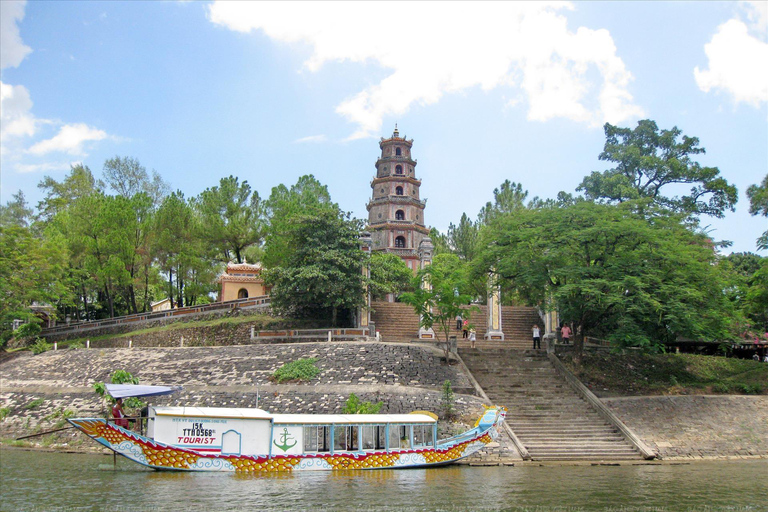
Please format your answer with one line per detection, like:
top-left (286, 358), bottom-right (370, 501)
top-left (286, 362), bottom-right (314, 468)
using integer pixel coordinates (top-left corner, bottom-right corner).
top-left (154, 407), bottom-right (437, 425)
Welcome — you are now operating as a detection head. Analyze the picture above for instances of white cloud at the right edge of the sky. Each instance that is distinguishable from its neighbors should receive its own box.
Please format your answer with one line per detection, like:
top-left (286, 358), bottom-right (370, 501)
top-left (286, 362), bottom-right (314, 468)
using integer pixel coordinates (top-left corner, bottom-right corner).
top-left (693, 15), bottom-right (768, 107)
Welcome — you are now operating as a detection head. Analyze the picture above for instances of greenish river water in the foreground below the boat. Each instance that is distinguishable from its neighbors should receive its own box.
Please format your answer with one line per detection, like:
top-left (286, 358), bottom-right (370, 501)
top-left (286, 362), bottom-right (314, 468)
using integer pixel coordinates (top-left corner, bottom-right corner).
top-left (0, 449), bottom-right (768, 512)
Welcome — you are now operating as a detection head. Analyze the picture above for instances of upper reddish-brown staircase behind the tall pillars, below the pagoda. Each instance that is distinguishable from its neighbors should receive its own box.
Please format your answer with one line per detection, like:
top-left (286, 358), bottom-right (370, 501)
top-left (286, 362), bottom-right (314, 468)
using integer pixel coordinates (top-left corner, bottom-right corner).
top-left (371, 302), bottom-right (542, 350)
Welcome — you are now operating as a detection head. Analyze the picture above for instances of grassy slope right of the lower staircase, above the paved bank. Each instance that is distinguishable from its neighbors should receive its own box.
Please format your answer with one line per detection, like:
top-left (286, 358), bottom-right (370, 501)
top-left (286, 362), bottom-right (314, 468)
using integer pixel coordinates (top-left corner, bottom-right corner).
top-left (563, 354), bottom-right (768, 396)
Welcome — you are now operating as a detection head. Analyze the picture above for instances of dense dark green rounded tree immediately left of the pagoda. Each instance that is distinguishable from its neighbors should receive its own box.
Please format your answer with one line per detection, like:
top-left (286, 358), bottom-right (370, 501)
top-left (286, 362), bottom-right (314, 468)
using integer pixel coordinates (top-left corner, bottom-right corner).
top-left (264, 208), bottom-right (365, 326)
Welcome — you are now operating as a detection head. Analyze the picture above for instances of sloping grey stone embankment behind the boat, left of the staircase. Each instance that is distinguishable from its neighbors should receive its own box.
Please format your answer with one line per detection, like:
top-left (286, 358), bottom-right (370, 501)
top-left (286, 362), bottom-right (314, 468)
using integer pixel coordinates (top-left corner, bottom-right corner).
top-left (0, 342), bottom-right (496, 454)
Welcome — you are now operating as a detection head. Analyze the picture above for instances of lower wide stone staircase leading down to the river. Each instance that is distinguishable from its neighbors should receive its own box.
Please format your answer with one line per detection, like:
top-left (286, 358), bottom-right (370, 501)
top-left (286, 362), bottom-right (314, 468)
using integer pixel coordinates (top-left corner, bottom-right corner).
top-left (459, 349), bottom-right (641, 461)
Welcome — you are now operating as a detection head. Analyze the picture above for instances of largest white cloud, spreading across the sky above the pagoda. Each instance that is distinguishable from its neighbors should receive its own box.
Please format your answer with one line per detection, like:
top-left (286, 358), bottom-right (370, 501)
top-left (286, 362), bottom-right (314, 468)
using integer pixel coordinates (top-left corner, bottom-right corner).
top-left (208, 1), bottom-right (643, 138)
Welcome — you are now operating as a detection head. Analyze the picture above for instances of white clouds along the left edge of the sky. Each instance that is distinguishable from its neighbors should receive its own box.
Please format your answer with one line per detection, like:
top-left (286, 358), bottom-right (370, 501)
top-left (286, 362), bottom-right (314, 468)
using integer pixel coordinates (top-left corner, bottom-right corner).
top-left (0, 0), bottom-right (110, 173)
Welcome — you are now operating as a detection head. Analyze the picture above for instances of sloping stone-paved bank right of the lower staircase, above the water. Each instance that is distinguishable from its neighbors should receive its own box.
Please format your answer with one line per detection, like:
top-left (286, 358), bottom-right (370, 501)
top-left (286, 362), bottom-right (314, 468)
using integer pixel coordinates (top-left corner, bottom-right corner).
top-left (601, 395), bottom-right (768, 459)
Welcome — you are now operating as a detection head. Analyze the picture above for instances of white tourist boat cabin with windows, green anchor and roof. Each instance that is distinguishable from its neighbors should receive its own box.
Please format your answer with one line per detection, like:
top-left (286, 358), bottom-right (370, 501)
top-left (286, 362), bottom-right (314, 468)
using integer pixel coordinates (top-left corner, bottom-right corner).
top-left (147, 407), bottom-right (437, 457)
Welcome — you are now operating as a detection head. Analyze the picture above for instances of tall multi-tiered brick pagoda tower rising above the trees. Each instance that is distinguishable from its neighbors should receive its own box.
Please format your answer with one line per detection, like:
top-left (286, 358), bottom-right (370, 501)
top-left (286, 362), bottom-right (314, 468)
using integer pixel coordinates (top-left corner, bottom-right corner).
top-left (366, 125), bottom-right (429, 273)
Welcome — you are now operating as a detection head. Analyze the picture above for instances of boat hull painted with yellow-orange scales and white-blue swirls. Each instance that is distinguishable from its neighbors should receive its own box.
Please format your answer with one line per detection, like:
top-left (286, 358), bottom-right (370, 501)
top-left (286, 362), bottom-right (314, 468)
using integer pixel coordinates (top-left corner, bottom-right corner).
top-left (68, 408), bottom-right (505, 473)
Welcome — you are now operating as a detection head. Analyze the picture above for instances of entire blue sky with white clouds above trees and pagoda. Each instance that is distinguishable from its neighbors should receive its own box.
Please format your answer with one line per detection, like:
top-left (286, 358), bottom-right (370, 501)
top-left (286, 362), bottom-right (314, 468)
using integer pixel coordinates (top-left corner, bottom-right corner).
top-left (0, 0), bottom-right (768, 252)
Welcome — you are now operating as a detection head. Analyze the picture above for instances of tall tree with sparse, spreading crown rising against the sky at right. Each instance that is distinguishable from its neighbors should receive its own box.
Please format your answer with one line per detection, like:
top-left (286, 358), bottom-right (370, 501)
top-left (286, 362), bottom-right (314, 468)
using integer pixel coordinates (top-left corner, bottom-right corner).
top-left (578, 119), bottom-right (738, 217)
